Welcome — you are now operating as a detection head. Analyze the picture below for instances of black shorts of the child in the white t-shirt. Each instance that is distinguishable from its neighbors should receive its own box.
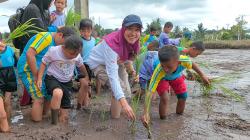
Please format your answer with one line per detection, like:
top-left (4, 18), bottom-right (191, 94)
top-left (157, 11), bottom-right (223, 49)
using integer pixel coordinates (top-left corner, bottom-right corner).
top-left (44, 75), bottom-right (73, 109)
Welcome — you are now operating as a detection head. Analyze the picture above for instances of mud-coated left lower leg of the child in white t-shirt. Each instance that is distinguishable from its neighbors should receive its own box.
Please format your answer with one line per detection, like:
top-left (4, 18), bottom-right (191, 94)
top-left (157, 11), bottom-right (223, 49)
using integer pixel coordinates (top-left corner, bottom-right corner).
top-left (51, 88), bottom-right (63, 124)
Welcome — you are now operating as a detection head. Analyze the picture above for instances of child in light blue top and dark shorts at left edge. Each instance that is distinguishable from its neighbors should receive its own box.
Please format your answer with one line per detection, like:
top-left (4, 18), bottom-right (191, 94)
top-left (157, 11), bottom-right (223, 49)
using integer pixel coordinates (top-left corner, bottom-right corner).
top-left (0, 42), bottom-right (17, 132)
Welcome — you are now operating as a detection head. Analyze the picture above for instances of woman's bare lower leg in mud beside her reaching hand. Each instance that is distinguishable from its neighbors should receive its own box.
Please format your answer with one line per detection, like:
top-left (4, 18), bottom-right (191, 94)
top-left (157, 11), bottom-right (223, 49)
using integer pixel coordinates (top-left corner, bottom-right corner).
top-left (110, 96), bottom-right (122, 119)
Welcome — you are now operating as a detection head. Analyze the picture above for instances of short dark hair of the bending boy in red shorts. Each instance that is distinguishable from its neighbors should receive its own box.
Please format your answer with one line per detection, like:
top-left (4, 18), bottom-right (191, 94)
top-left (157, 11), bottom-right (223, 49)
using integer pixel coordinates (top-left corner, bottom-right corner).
top-left (158, 45), bottom-right (179, 62)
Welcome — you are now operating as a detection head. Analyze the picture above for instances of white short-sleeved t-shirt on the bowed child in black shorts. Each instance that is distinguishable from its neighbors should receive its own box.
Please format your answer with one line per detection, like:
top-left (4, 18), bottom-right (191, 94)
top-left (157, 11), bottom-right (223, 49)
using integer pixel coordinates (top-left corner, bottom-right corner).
top-left (42, 46), bottom-right (83, 83)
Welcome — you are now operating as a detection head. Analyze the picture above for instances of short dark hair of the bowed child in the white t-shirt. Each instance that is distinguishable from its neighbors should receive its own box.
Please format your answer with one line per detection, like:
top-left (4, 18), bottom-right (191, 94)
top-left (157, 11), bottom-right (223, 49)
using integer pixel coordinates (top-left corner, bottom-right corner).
top-left (65, 35), bottom-right (82, 51)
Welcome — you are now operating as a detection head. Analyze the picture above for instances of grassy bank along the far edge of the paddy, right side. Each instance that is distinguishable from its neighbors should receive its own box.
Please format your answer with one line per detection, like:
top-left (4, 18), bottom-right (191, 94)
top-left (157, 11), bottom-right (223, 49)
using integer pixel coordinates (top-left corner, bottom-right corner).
top-left (204, 40), bottom-right (250, 49)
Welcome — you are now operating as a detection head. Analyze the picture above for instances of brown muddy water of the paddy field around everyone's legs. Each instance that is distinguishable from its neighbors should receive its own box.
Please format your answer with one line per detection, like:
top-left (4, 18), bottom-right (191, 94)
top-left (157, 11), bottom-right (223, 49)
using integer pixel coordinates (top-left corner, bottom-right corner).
top-left (0, 50), bottom-right (250, 140)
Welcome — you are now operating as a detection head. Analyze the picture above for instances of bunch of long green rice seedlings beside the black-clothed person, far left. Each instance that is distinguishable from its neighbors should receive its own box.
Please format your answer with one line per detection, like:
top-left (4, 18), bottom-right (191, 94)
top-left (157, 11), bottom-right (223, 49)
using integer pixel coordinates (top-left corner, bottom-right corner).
top-left (5, 18), bottom-right (44, 43)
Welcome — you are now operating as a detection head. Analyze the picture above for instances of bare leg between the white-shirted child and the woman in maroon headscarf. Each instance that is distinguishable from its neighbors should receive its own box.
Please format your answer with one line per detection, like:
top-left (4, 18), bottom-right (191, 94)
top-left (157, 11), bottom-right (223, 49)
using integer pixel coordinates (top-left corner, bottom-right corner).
top-left (77, 78), bottom-right (90, 109)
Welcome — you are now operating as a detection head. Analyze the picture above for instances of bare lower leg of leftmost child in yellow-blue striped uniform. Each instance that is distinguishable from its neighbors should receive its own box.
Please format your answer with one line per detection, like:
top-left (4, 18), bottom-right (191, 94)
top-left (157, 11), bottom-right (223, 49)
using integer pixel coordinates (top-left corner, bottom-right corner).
top-left (31, 98), bottom-right (44, 122)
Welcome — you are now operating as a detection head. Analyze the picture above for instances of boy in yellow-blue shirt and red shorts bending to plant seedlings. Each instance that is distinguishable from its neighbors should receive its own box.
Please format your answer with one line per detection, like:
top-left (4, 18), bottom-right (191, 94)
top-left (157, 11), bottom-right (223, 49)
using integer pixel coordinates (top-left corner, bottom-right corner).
top-left (142, 46), bottom-right (210, 125)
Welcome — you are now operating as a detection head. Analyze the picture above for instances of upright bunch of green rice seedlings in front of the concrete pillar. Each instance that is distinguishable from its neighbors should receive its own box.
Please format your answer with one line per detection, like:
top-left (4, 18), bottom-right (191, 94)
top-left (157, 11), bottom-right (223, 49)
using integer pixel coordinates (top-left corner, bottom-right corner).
top-left (65, 7), bottom-right (81, 26)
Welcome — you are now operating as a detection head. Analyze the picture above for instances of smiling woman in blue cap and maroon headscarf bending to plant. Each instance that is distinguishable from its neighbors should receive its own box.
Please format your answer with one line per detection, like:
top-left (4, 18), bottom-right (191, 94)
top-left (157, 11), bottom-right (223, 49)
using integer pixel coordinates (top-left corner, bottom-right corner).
top-left (87, 15), bottom-right (142, 120)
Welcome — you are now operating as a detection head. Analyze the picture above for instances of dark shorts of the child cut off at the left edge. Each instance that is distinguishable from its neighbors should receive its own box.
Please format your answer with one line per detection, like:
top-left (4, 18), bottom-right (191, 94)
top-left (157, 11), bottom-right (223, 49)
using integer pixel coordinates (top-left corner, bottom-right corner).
top-left (0, 67), bottom-right (17, 96)
